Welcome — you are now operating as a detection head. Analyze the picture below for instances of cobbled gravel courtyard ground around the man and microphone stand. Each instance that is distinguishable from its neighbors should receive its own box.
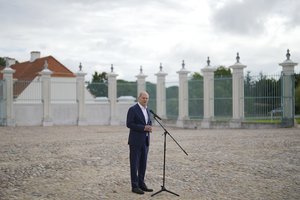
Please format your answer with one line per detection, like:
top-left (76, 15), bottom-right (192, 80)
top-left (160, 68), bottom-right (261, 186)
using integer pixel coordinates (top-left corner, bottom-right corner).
top-left (0, 126), bottom-right (300, 200)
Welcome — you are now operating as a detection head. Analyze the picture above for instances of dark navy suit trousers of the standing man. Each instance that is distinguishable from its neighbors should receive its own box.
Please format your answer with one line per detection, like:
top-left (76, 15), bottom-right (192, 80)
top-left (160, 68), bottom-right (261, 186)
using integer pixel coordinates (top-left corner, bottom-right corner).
top-left (129, 143), bottom-right (149, 188)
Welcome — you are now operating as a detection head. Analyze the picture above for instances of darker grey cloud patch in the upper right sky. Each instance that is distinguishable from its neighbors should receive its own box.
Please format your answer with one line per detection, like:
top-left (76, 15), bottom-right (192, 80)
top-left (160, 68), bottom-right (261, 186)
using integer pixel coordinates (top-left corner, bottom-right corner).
top-left (211, 0), bottom-right (300, 35)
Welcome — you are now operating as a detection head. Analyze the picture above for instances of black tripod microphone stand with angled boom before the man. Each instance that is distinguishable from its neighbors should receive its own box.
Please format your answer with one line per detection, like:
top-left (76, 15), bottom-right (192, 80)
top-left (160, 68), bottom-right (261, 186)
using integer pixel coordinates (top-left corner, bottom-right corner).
top-left (151, 115), bottom-right (188, 197)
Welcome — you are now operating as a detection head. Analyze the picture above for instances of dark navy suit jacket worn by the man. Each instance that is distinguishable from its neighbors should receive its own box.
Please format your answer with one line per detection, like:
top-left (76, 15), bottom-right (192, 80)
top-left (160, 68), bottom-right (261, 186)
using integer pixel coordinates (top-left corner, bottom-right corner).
top-left (126, 103), bottom-right (152, 145)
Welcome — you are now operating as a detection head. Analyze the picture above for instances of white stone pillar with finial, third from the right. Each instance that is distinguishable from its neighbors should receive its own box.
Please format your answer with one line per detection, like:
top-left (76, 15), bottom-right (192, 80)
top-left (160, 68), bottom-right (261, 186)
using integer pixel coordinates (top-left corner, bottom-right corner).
top-left (201, 57), bottom-right (216, 128)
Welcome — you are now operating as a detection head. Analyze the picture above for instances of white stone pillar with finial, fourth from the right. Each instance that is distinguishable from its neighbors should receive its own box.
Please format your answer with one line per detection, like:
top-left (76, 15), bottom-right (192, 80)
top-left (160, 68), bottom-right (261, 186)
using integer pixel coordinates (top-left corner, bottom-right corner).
top-left (176, 61), bottom-right (190, 127)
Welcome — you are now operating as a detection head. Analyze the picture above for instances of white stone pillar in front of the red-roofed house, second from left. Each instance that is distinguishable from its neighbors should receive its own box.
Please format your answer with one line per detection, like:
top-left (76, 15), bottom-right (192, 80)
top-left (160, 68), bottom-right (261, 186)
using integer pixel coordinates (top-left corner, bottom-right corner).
top-left (39, 60), bottom-right (53, 126)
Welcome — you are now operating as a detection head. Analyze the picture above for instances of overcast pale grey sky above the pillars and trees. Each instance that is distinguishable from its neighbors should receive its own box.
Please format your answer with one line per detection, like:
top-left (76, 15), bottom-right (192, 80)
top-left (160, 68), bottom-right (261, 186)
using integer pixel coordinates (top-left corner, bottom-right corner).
top-left (0, 0), bottom-right (300, 81)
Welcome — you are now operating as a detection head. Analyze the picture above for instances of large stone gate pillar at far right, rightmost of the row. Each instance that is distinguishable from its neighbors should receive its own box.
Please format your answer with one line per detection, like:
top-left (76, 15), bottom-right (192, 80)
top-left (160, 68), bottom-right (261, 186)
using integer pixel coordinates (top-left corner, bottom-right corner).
top-left (279, 50), bottom-right (298, 127)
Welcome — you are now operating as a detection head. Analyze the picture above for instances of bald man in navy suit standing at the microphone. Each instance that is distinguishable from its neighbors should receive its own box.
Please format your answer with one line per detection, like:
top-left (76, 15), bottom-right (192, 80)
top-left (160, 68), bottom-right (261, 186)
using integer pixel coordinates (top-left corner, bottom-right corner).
top-left (126, 91), bottom-right (153, 194)
